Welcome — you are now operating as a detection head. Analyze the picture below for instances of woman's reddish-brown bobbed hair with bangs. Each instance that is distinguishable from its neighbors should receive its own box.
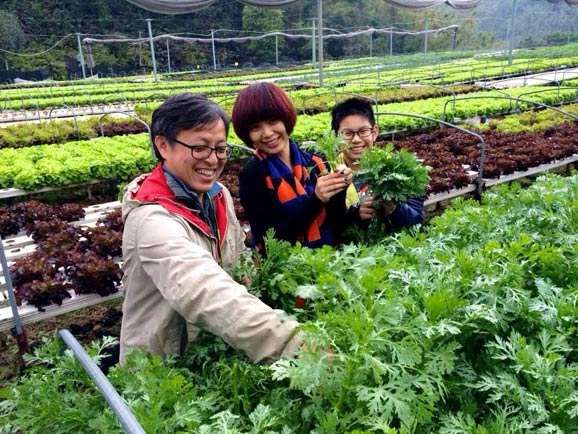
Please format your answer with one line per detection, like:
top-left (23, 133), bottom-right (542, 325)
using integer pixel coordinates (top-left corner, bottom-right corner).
top-left (232, 82), bottom-right (297, 146)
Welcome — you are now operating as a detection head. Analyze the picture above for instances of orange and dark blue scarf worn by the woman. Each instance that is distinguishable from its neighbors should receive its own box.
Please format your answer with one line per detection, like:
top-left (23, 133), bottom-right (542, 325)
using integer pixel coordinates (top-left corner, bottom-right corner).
top-left (258, 141), bottom-right (334, 247)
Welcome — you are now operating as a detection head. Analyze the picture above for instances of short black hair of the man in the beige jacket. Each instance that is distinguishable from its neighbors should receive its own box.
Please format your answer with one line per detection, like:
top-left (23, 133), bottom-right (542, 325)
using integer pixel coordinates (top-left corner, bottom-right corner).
top-left (151, 93), bottom-right (230, 161)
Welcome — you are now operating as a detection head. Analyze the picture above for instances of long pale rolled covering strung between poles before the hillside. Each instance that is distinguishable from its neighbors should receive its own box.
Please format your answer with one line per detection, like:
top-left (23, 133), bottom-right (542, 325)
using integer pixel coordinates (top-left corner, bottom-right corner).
top-left (83, 25), bottom-right (459, 44)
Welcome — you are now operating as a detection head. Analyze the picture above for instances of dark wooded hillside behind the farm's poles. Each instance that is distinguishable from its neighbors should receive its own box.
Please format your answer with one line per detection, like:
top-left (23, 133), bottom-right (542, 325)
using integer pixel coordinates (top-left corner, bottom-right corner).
top-left (0, 0), bottom-right (578, 81)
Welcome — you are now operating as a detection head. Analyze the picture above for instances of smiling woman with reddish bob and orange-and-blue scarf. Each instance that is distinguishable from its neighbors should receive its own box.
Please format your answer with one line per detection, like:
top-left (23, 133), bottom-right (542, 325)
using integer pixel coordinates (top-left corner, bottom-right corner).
top-left (233, 82), bottom-right (351, 248)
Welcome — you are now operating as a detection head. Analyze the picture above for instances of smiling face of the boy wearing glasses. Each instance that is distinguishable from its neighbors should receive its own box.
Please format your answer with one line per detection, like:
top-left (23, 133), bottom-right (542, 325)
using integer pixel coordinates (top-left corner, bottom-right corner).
top-left (338, 115), bottom-right (379, 166)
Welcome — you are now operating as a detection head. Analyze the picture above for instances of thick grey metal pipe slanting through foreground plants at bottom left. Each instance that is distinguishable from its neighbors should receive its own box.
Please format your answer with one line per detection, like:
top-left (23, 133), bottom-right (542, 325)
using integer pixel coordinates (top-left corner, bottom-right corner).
top-left (58, 329), bottom-right (146, 434)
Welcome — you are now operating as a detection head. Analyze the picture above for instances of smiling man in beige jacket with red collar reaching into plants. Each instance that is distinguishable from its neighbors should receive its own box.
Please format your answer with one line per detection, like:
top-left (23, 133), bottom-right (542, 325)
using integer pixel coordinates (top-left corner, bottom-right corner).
top-left (120, 94), bottom-right (301, 362)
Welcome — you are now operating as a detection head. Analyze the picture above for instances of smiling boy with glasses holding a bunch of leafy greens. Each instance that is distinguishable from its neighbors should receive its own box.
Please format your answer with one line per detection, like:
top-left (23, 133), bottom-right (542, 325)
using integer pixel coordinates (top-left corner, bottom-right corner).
top-left (331, 98), bottom-right (423, 230)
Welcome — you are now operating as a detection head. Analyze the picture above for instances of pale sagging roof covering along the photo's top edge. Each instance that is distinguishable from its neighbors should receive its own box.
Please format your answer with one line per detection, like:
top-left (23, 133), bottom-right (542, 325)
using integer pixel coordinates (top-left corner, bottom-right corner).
top-left (127, 0), bottom-right (482, 15)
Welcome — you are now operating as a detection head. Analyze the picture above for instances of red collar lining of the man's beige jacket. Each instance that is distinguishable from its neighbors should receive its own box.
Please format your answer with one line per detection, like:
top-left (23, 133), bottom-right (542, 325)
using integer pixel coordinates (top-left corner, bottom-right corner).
top-left (133, 164), bottom-right (229, 247)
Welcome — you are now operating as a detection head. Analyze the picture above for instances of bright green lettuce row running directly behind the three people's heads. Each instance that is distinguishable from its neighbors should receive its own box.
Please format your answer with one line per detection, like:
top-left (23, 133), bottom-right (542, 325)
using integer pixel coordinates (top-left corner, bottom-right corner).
top-left (0, 82), bottom-right (576, 190)
